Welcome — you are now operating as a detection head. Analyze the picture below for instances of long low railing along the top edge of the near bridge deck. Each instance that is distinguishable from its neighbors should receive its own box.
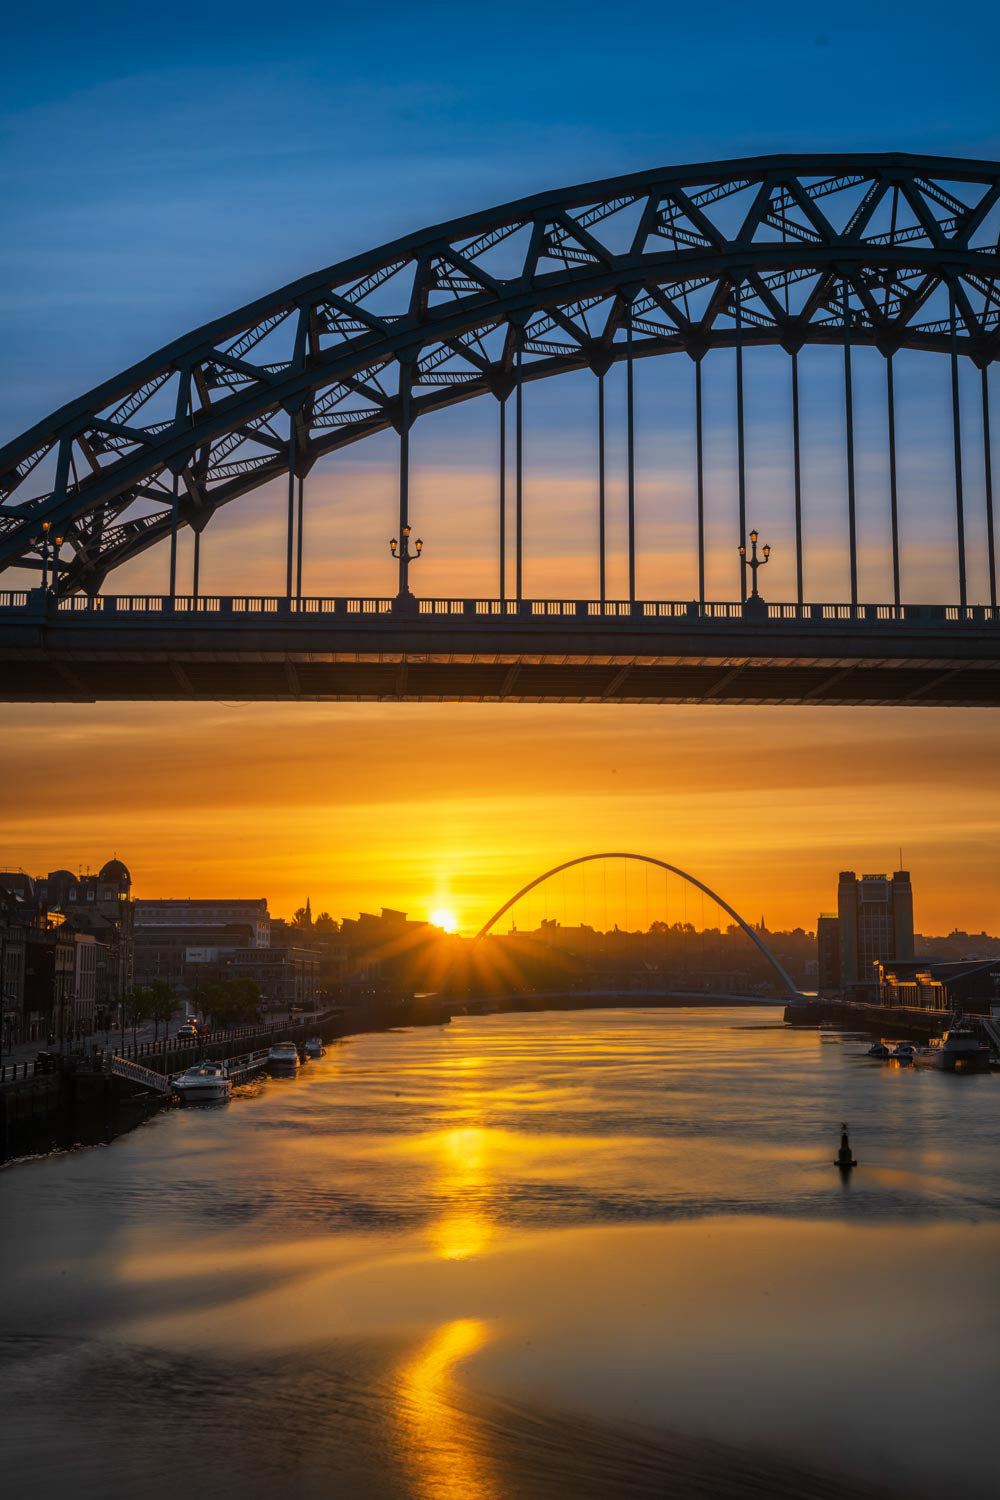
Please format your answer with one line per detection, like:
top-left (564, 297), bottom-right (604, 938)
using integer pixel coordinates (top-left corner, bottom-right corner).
top-left (0, 588), bottom-right (1000, 626)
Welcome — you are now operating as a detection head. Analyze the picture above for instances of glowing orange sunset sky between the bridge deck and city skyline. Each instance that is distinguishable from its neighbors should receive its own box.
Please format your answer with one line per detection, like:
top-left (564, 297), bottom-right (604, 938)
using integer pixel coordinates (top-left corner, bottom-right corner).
top-left (0, 704), bottom-right (1000, 933)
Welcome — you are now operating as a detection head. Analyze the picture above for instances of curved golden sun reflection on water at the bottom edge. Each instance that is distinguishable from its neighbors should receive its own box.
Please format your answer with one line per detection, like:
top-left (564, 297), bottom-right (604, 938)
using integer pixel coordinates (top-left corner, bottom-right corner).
top-left (396, 1317), bottom-right (499, 1500)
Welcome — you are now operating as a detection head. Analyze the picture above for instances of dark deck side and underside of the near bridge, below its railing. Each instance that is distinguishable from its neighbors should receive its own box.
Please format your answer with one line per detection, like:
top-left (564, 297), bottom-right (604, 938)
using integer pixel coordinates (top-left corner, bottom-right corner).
top-left (0, 617), bottom-right (1000, 707)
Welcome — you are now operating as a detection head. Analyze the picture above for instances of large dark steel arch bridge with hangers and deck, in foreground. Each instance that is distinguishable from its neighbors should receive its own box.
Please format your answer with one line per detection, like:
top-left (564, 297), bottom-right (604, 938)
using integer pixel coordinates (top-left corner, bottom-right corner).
top-left (0, 155), bottom-right (1000, 704)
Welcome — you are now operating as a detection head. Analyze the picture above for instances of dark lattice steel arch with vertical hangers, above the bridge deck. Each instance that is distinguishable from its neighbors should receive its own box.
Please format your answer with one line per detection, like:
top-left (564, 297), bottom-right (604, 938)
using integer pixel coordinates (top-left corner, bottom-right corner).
top-left (0, 155), bottom-right (1000, 609)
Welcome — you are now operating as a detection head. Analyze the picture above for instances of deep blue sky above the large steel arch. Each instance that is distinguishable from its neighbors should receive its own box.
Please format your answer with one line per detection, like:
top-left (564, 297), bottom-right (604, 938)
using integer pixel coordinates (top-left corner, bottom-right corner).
top-left (0, 0), bottom-right (1000, 437)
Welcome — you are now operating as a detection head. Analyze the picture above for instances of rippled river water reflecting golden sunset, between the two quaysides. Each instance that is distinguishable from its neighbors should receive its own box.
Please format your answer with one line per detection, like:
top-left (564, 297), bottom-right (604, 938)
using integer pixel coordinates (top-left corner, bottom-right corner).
top-left (0, 1008), bottom-right (1000, 1500)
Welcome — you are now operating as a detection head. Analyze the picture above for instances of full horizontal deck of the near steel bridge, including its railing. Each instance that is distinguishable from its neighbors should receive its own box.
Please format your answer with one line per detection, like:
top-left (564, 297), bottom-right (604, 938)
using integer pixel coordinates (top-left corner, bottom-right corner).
top-left (0, 594), bottom-right (1000, 707)
